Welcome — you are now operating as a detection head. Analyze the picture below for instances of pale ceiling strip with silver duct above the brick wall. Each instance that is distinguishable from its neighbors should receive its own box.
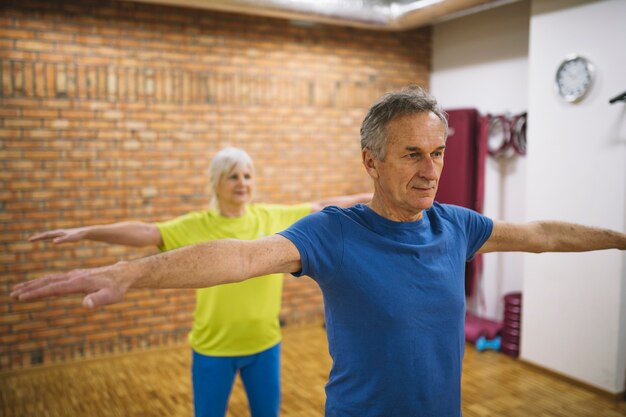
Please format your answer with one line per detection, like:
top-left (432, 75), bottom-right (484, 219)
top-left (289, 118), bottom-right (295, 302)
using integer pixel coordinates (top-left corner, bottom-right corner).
top-left (124, 0), bottom-right (517, 30)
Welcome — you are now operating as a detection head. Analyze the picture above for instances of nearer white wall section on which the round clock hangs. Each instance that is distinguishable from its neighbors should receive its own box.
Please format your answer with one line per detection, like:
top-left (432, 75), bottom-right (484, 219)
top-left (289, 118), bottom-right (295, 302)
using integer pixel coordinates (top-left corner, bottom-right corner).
top-left (522, 0), bottom-right (626, 393)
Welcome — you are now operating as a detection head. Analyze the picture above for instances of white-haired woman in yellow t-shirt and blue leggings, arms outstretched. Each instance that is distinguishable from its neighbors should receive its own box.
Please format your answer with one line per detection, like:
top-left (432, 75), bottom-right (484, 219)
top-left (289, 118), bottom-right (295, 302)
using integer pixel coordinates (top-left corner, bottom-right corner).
top-left (30, 148), bottom-right (371, 417)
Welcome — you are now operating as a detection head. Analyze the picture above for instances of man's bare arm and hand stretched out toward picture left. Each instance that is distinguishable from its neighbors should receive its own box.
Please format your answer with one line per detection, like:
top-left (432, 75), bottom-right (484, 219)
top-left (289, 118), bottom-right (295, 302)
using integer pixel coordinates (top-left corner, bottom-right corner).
top-left (11, 235), bottom-right (301, 308)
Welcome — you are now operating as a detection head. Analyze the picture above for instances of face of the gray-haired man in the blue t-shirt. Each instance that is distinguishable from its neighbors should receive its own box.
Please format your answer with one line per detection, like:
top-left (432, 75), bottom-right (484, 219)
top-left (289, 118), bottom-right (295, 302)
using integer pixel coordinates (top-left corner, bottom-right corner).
top-left (364, 112), bottom-right (446, 221)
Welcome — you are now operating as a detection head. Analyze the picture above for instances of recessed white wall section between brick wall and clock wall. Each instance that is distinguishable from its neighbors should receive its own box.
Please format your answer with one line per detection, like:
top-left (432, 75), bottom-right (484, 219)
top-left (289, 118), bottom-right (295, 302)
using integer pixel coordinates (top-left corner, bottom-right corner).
top-left (430, 1), bottom-right (530, 320)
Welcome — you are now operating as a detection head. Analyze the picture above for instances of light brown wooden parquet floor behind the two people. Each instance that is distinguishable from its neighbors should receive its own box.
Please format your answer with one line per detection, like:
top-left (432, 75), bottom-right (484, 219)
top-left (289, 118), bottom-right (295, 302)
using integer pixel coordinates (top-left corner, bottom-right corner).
top-left (0, 326), bottom-right (626, 417)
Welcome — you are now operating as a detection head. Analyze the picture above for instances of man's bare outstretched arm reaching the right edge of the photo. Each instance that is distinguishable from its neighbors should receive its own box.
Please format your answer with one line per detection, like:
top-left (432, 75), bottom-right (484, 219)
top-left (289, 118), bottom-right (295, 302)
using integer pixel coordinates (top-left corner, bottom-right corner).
top-left (479, 221), bottom-right (626, 253)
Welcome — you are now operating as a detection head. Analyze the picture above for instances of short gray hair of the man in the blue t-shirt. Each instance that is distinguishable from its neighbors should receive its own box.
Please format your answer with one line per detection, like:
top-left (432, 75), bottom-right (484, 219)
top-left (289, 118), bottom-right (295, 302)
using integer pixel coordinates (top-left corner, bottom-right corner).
top-left (361, 86), bottom-right (448, 161)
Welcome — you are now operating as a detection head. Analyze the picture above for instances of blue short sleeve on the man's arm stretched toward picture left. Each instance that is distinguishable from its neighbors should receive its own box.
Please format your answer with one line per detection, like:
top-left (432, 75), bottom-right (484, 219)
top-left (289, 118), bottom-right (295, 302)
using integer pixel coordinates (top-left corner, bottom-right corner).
top-left (279, 207), bottom-right (344, 282)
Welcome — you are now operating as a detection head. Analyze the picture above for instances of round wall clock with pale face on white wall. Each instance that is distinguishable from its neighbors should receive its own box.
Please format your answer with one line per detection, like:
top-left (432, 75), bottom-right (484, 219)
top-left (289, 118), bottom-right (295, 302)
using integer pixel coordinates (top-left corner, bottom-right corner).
top-left (556, 55), bottom-right (594, 103)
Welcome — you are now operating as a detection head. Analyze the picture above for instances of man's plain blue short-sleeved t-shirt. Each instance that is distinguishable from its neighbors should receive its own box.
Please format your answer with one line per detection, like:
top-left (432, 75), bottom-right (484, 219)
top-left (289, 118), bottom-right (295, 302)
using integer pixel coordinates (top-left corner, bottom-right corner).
top-left (280, 203), bottom-right (493, 417)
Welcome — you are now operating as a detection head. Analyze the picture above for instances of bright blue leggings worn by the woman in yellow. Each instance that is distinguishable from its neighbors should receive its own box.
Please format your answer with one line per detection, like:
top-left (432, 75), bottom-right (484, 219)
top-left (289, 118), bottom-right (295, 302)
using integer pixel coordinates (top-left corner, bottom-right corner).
top-left (191, 343), bottom-right (280, 417)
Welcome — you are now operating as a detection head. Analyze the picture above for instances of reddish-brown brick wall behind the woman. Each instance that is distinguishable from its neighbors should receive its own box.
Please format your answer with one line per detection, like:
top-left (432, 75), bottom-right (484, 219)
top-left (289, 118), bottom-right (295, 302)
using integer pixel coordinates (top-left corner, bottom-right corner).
top-left (0, 0), bottom-right (430, 369)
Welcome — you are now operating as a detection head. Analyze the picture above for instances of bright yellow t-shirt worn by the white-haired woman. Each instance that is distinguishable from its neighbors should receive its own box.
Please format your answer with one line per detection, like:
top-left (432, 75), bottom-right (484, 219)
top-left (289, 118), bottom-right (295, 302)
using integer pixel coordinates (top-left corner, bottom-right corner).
top-left (156, 203), bottom-right (311, 356)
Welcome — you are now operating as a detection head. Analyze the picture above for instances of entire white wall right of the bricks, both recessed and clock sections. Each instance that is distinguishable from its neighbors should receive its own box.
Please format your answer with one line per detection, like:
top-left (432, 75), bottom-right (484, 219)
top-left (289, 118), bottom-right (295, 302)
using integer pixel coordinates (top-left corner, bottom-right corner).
top-left (431, 0), bottom-right (626, 393)
